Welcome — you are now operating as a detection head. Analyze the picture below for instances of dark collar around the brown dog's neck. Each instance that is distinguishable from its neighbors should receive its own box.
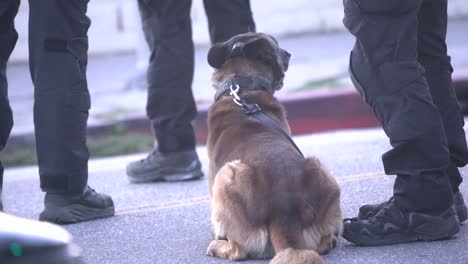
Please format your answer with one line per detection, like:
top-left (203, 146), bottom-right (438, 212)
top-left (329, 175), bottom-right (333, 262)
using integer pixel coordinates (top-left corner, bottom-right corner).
top-left (214, 75), bottom-right (275, 102)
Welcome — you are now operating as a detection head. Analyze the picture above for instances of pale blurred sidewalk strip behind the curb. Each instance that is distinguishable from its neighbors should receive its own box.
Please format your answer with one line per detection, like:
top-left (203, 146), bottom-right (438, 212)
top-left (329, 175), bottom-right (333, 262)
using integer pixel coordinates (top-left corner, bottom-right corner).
top-left (8, 19), bottom-right (468, 135)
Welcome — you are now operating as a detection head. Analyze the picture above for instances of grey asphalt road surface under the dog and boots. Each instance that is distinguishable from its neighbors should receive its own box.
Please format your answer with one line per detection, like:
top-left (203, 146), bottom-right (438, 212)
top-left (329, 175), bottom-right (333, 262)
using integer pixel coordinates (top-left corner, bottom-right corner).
top-left (4, 129), bottom-right (468, 264)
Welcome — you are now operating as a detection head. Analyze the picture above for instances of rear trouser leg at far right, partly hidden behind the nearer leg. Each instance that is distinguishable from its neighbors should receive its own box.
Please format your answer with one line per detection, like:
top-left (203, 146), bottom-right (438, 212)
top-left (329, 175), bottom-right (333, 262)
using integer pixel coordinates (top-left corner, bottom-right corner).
top-left (418, 0), bottom-right (468, 193)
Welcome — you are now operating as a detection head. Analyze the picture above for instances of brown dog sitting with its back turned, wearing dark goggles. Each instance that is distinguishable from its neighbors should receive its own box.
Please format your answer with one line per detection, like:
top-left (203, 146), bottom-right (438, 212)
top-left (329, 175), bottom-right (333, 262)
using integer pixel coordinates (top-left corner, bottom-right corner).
top-left (207, 33), bottom-right (342, 264)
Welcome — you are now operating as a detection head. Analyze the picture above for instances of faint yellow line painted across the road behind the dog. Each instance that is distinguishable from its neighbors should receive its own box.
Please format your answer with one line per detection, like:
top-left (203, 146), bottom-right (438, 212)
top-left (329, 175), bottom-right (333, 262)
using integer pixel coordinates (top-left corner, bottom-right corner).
top-left (116, 171), bottom-right (386, 215)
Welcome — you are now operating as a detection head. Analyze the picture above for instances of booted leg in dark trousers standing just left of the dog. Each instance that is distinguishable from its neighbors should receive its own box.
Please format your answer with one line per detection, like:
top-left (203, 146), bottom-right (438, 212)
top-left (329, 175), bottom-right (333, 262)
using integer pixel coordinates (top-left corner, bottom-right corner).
top-left (127, 0), bottom-right (202, 182)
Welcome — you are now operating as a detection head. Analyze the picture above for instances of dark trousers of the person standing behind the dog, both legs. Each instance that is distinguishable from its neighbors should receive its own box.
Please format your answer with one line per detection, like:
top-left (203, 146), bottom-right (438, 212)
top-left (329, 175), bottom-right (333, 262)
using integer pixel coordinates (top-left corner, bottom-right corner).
top-left (138, 0), bottom-right (255, 153)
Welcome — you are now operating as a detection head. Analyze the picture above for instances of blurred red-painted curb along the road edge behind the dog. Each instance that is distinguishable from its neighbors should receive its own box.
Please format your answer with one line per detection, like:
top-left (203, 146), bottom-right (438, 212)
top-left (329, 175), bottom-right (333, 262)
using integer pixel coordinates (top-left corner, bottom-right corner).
top-left (9, 78), bottom-right (468, 146)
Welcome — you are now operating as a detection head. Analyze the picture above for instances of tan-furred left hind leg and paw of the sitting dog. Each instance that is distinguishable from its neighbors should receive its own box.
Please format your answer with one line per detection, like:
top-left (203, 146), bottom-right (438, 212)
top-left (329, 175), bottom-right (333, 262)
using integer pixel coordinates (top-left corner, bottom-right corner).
top-left (207, 161), bottom-right (271, 260)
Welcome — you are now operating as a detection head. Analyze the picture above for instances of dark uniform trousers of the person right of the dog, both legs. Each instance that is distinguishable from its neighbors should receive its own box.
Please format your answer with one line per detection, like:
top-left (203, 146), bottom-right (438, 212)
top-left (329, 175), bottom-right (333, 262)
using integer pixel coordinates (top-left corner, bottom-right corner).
top-left (344, 0), bottom-right (468, 213)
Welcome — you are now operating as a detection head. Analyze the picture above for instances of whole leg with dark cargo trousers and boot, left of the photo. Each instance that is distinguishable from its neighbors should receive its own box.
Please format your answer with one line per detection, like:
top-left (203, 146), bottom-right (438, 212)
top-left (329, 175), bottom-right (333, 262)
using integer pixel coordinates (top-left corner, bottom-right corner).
top-left (29, 0), bottom-right (114, 223)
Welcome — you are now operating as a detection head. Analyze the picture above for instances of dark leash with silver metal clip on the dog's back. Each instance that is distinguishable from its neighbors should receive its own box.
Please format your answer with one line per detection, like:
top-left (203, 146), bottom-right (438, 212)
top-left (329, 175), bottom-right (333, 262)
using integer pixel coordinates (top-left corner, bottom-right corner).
top-left (229, 81), bottom-right (304, 157)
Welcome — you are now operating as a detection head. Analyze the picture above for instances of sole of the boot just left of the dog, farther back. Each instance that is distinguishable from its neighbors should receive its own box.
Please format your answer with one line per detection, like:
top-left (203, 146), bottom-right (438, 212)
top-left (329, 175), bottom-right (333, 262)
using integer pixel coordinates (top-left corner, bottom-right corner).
top-left (127, 168), bottom-right (203, 183)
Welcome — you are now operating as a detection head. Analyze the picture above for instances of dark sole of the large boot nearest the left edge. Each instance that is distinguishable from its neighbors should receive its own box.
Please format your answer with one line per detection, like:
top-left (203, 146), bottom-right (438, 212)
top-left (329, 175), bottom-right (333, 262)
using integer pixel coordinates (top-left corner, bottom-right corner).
top-left (39, 204), bottom-right (115, 225)
